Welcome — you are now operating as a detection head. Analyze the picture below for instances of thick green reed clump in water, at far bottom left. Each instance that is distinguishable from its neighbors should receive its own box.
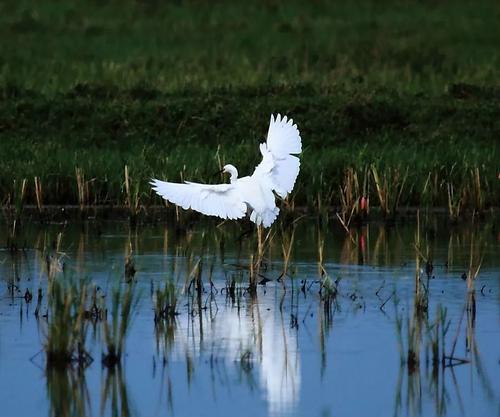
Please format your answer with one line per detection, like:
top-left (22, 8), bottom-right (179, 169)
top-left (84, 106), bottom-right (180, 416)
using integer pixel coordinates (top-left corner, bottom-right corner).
top-left (44, 277), bottom-right (92, 367)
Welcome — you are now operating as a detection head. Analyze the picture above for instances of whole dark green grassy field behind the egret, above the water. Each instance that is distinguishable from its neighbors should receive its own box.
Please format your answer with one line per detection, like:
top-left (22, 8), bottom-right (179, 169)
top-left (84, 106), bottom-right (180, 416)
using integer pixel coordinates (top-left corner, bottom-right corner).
top-left (0, 0), bottom-right (500, 209)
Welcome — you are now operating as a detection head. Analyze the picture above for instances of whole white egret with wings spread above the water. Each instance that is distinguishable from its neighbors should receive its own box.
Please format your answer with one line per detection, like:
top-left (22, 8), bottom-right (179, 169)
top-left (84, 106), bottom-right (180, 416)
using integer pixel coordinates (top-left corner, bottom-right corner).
top-left (151, 114), bottom-right (302, 227)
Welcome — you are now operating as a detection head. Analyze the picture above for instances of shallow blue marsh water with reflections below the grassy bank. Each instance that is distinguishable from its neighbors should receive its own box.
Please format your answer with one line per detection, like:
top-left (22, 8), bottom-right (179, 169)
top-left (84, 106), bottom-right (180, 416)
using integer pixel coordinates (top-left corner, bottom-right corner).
top-left (0, 218), bottom-right (500, 416)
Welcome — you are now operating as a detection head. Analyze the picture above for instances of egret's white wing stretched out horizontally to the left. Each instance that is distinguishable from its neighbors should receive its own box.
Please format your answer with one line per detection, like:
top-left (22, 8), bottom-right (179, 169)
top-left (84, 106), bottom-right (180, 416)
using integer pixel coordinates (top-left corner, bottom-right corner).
top-left (151, 179), bottom-right (247, 219)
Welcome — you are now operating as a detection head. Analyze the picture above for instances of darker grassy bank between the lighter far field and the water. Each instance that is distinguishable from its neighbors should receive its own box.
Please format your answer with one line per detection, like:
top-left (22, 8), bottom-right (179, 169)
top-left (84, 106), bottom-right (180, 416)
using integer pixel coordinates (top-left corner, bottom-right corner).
top-left (0, 85), bottom-right (500, 210)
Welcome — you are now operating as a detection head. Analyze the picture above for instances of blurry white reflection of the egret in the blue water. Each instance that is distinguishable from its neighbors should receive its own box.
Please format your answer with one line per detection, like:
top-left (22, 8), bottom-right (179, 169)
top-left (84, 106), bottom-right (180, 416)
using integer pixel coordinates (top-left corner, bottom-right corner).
top-left (156, 290), bottom-right (301, 415)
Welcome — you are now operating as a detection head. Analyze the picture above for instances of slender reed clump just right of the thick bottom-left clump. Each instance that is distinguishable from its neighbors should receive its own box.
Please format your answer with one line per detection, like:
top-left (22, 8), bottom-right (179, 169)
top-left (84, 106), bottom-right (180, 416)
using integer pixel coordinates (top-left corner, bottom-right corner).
top-left (102, 283), bottom-right (139, 367)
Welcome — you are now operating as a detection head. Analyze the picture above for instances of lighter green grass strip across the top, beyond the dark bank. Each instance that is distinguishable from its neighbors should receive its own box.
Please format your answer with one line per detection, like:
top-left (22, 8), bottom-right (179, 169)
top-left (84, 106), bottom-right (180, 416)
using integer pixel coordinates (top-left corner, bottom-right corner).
top-left (0, 0), bottom-right (500, 92)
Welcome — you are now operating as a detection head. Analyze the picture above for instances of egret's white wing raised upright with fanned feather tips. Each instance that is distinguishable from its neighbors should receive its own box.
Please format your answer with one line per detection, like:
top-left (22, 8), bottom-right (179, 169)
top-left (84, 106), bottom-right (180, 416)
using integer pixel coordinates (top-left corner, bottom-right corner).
top-left (253, 114), bottom-right (302, 198)
